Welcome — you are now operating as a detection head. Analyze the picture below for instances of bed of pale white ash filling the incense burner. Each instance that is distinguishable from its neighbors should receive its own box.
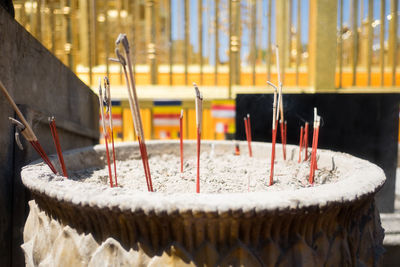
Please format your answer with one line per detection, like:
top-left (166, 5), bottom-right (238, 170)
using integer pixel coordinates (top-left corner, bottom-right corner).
top-left (70, 152), bottom-right (339, 194)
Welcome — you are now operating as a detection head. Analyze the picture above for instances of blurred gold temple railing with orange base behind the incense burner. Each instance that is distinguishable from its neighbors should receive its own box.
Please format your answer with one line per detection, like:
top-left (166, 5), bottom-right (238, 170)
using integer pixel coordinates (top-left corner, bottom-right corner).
top-left (13, 0), bottom-right (400, 92)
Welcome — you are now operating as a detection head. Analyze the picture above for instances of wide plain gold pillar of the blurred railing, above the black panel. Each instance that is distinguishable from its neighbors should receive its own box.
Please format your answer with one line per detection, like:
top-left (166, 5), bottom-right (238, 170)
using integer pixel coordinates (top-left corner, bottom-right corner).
top-left (309, 0), bottom-right (337, 91)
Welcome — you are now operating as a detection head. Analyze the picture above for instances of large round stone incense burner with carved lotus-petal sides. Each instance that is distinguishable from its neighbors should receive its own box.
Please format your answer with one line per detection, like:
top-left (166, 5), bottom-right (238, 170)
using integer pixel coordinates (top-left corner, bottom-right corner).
top-left (21, 141), bottom-right (385, 266)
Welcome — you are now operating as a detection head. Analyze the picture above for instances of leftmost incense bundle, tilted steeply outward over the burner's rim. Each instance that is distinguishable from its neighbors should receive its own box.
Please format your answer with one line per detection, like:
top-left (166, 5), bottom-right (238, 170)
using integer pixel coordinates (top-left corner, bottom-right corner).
top-left (0, 81), bottom-right (57, 174)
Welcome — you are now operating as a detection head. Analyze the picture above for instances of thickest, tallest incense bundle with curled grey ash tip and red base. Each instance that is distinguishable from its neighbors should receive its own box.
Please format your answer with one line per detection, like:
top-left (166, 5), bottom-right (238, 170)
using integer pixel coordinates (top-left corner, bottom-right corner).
top-left (111, 34), bottom-right (153, 192)
